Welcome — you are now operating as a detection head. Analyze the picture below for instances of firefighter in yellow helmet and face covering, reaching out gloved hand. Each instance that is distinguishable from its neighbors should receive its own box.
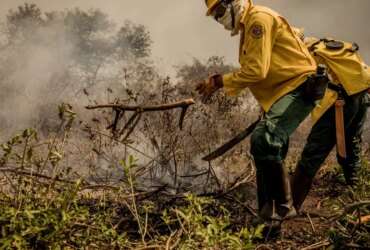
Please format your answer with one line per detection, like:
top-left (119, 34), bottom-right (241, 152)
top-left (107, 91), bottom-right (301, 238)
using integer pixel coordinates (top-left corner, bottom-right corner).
top-left (196, 0), bottom-right (316, 232)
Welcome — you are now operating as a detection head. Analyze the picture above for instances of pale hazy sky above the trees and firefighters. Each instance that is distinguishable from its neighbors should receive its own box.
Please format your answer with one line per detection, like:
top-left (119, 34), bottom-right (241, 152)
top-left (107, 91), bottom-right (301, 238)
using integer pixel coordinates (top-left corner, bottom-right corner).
top-left (0, 0), bottom-right (370, 74)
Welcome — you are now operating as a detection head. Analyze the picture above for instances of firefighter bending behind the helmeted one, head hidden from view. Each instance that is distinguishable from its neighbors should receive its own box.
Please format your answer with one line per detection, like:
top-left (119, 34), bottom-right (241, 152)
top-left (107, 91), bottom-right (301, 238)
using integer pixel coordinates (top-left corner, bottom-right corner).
top-left (292, 29), bottom-right (370, 211)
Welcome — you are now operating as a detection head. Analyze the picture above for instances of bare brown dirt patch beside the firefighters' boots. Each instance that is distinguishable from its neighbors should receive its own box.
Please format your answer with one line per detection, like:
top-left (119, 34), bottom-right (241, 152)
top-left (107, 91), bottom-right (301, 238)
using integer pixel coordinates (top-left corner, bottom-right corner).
top-left (251, 177), bottom-right (350, 250)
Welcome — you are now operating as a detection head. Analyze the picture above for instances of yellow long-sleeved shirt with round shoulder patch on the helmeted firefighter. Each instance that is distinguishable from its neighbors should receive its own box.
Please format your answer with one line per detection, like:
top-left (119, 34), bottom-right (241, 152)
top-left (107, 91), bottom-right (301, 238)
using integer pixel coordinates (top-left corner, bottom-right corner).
top-left (223, 5), bottom-right (316, 111)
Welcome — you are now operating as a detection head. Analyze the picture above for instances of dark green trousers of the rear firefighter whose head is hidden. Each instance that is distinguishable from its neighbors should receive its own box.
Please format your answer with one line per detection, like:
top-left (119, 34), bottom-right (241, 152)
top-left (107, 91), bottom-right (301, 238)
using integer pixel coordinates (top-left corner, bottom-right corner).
top-left (297, 92), bottom-right (370, 185)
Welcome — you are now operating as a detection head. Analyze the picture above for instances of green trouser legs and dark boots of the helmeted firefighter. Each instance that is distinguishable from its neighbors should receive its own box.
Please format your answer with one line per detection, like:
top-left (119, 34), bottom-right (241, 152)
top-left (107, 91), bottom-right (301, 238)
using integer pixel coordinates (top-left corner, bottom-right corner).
top-left (251, 85), bottom-right (314, 220)
